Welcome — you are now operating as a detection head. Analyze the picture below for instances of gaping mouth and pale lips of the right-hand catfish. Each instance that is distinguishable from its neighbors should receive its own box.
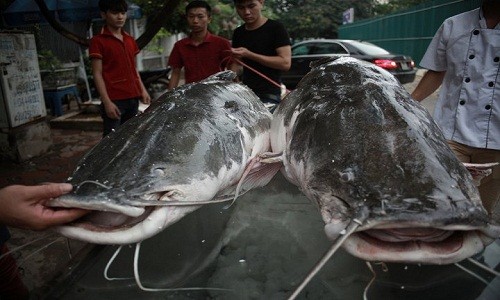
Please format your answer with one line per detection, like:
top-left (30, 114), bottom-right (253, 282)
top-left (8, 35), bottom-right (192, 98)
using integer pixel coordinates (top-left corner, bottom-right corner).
top-left (343, 227), bottom-right (491, 264)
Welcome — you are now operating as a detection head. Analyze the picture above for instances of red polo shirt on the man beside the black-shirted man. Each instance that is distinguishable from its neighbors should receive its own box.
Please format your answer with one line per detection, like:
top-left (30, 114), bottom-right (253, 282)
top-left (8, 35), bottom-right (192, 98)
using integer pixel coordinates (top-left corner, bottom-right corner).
top-left (168, 32), bottom-right (231, 83)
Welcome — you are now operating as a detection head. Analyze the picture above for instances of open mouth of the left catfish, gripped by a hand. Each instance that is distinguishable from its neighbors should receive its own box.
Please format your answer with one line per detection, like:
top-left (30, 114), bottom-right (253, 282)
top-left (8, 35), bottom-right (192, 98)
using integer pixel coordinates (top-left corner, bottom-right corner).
top-left (51, 190), bottom-right (205, 245)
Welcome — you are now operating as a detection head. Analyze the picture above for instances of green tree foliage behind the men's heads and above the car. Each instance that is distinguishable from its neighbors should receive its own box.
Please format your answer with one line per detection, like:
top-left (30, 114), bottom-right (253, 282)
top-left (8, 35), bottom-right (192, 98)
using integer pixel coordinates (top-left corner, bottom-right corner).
top-left (134, 0), bottom-right (426, 40)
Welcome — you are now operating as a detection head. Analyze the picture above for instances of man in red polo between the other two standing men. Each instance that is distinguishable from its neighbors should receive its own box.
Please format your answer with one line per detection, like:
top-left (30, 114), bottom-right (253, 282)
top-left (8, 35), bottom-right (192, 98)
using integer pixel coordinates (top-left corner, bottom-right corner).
top-left (168, 1), bottom-right (231, 89)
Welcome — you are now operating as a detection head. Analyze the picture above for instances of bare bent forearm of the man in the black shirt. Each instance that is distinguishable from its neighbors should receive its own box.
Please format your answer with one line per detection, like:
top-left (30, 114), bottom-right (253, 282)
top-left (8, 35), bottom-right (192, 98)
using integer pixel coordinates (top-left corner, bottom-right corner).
top-left (231, 45), bottom-right (292, 71)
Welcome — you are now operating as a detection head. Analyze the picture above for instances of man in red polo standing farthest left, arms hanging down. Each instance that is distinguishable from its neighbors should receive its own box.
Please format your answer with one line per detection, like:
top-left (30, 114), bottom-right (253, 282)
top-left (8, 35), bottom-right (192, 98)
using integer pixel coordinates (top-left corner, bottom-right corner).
top-left (89, 0), bottom-right (151, 137)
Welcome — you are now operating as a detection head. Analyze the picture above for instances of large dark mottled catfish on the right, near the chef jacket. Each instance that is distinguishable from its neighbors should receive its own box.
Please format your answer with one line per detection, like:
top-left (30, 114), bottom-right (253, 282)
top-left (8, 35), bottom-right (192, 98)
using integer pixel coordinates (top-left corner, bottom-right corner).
top-left (271, 58), bottom-right (498, 263)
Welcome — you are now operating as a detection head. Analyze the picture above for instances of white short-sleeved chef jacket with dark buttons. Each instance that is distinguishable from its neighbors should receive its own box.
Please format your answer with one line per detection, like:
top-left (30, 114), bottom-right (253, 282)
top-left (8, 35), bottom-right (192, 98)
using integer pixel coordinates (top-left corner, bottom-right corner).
top-left (420, 8), bottom-right (500, 150)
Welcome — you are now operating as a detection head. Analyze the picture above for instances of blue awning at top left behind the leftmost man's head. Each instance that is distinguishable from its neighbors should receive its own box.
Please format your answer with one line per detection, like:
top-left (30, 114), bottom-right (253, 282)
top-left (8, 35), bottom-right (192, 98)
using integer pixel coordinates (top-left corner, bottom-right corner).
top-left (2, 0), bottom-right (142, 27)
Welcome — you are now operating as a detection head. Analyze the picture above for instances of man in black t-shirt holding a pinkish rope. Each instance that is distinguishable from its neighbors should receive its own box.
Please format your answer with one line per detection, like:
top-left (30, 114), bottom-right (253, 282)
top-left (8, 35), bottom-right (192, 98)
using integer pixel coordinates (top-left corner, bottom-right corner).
top-left (231, 0), bottom-right (292, 110)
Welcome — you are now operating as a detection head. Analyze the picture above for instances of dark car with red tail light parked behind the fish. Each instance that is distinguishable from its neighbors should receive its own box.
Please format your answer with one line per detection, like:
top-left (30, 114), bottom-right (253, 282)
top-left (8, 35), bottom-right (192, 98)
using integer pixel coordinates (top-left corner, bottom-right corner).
top-left (282, 39), bottom-right (417, 89)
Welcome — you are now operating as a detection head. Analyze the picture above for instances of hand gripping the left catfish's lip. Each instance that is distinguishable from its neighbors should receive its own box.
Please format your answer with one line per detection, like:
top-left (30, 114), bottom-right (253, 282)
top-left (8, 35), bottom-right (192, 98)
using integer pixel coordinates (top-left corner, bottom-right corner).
top-left (0, 183), bottom-right (89, 230)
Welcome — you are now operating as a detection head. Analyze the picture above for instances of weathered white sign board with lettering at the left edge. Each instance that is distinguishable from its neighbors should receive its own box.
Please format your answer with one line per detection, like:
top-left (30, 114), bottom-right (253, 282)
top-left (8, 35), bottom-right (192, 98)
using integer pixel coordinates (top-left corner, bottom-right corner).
top-left (0, 32), bottom-right (47, 127)
